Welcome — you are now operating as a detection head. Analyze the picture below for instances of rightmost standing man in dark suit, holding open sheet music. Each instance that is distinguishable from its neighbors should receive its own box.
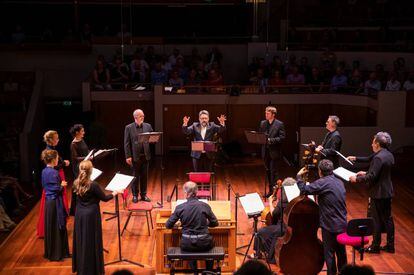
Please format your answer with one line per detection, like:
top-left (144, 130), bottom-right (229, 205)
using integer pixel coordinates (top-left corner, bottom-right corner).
top-left (348, 132), bottom-right (395, 253)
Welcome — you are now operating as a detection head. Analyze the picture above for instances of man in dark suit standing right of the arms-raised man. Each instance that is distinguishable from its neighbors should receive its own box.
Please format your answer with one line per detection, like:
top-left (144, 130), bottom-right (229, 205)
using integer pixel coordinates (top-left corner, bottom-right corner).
top-left (260, 106), bottom-right (286, 197)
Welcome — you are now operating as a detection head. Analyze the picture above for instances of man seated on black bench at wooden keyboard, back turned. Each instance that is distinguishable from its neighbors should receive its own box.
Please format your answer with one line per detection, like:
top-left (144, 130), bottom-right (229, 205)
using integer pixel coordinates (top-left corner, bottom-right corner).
top-left (165, 181), bottom-right (218, 274)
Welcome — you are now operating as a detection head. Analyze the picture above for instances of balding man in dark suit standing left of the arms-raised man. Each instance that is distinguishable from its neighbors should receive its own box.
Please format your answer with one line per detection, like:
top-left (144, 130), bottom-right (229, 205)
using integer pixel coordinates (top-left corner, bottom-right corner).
top-left (124, 109), bottom-right (153, 203)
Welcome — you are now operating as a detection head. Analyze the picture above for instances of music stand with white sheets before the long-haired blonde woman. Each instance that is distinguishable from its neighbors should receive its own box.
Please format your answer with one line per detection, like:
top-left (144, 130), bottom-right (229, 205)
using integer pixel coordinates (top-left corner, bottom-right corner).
top-left (105, 173), bottom-right (144, 267)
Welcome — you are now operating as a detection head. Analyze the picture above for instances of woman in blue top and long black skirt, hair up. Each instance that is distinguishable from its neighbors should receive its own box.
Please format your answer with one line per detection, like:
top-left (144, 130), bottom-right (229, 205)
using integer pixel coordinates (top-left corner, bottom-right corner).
top-left (42, 149), bottom-right (70, 261)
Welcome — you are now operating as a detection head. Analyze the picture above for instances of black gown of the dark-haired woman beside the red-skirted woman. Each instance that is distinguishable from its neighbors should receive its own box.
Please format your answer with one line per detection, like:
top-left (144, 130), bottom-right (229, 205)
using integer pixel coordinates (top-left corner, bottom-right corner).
top-left (69, 139), bottom-right (89, 216)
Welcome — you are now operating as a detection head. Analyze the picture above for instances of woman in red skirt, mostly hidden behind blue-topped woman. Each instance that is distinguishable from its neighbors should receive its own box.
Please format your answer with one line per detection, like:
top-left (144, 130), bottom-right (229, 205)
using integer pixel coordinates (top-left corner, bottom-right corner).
top-left (37, 130), bottom-right (70, 238)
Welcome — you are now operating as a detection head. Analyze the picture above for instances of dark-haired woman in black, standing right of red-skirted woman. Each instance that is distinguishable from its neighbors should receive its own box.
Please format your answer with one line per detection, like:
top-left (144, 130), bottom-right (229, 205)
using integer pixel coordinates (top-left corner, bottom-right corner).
top-left (69, 124), bottom-right (89, 216)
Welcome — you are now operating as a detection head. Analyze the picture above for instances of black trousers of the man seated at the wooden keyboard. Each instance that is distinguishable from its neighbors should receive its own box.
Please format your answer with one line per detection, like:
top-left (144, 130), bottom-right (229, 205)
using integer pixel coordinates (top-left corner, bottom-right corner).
top-left (180, 235), bottom-right (214, 274)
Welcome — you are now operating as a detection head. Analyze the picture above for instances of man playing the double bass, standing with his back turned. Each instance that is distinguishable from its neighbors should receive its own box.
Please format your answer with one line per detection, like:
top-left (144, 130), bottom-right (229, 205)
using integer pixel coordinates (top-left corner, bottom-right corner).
top-left (297, 159), bottom-right (347, 275)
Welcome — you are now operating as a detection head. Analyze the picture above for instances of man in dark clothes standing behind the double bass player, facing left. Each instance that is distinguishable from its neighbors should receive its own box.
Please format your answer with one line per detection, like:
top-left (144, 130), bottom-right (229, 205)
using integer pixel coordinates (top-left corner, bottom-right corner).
top-left (315, 116), bottom-right (342, 168)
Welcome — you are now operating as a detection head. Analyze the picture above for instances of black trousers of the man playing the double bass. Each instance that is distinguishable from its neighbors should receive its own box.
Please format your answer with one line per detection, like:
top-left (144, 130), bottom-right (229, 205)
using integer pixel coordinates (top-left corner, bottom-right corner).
top-left (322, 228), bottom-right (347, 275)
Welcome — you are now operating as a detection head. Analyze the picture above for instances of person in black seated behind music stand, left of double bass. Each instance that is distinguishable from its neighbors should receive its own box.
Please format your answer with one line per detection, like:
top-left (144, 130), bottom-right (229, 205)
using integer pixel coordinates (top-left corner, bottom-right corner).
top-left (249, 178), bottom-right (296, 264)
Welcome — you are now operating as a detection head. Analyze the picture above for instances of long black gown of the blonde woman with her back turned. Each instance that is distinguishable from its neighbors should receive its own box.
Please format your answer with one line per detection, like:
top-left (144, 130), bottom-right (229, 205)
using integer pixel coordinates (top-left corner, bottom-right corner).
top-left (72, 181), bottom-right (113, 275)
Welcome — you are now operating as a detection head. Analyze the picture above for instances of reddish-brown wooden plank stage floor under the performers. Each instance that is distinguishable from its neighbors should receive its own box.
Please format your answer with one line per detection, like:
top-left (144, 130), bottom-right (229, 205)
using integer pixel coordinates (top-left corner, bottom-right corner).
top-left (0, 156), bottom-right (414, 274)
